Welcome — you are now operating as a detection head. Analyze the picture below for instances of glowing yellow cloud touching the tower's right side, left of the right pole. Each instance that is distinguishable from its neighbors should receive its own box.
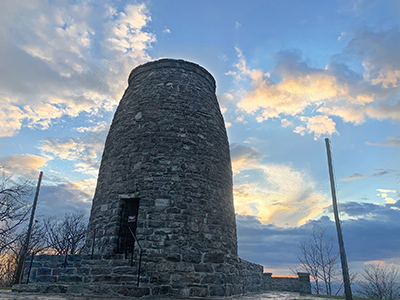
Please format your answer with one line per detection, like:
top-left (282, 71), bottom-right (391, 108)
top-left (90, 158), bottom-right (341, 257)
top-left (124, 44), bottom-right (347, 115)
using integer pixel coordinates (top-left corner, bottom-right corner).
top-left (231, 144), bottom-right (327, 226)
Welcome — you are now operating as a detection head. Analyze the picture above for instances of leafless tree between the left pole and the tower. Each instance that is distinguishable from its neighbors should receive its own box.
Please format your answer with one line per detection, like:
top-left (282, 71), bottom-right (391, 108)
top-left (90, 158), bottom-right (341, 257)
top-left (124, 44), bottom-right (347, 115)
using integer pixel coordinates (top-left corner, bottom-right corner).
top-left (44, 211), bottom-right (87, 255)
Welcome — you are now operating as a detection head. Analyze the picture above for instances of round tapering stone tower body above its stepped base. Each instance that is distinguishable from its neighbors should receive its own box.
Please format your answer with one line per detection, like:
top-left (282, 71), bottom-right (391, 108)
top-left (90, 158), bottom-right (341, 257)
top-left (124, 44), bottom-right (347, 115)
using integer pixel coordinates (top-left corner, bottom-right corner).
top-left (87, 59), bottom-right (237, 262)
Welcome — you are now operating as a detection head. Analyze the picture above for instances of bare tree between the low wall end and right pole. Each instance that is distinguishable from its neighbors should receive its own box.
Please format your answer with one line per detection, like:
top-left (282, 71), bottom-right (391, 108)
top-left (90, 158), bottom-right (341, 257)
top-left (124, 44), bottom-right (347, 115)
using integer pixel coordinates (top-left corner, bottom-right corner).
top-left (297, 226), bottom-right (339, 295)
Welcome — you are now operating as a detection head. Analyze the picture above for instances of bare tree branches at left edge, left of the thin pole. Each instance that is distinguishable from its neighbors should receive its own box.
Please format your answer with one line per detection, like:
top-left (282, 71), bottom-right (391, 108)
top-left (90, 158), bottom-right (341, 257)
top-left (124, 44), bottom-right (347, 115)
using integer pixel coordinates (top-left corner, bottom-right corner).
top-left (0, 168), bottom-right (32, 253)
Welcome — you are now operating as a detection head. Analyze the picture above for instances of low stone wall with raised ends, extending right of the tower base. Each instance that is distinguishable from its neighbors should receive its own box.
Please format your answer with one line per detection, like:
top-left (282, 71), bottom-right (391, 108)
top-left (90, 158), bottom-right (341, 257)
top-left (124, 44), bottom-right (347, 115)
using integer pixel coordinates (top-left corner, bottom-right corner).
top-left (263, 272), bottom-right (311, 294)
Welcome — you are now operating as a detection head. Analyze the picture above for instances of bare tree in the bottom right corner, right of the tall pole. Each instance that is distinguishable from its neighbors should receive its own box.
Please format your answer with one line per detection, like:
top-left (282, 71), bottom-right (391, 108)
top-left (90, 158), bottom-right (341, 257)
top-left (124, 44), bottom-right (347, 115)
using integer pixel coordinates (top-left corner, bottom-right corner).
top-left (359, 263), bottom-right (400, 300)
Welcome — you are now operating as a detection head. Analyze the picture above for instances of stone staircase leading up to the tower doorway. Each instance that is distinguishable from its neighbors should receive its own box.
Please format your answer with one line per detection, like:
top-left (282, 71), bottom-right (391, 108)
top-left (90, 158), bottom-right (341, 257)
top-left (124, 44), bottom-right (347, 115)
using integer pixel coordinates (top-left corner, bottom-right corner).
top-left (13, 254), bottom-right (150, 297)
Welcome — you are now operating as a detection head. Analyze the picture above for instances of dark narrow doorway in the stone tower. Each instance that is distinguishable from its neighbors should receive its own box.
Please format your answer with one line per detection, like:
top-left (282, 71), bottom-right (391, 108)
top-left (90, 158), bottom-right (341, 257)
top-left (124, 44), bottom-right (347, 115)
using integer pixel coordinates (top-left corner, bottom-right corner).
top-left (117, 198), bottom-right (140, 256)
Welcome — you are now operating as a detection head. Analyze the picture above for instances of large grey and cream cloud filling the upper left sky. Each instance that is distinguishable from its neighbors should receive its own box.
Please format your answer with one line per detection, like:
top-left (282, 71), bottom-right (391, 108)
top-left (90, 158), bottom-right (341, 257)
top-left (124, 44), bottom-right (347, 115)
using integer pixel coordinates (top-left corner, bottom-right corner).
top-left (0, 1), bottom-right (155, 136)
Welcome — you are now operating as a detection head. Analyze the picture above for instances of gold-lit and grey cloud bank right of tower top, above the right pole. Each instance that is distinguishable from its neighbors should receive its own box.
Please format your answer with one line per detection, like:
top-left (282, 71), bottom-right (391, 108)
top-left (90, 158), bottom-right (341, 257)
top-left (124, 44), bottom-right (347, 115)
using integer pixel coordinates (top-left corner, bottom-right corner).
top-left (230, 28), bottom-right (400, 139)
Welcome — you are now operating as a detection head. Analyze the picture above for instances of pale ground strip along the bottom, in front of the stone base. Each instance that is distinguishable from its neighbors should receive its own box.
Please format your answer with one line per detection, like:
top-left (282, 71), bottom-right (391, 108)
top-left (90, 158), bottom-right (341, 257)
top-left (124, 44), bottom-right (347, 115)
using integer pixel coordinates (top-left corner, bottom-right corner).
top-left (0, 290), bottom-right (329, 300)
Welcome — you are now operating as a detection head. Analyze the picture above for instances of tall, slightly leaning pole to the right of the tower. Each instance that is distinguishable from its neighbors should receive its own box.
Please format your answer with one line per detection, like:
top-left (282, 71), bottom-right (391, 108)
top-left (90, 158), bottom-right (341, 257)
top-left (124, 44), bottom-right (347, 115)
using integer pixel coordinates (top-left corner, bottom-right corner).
top-left (325, 138), bottom-right (353, 300)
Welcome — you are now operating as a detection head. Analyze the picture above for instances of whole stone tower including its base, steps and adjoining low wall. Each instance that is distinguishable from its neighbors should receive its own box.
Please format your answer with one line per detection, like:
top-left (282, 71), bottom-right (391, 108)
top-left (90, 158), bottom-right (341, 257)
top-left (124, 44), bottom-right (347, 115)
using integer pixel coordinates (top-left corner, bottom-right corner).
top-left (13, 59), bottom-right (310, 297)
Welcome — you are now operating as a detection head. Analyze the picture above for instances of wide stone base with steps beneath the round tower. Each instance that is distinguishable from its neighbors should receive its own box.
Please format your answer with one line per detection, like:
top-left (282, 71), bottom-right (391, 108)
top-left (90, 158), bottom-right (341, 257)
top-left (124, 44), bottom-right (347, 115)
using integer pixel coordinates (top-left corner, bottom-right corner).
top-left (13, 253), bottom-right (263, 297)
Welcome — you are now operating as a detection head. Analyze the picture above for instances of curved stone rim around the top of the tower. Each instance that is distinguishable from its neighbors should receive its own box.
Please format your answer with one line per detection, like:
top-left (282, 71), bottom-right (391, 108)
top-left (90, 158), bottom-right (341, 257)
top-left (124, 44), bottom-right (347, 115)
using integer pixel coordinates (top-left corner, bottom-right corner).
top-left (128, 58), bottom-right (216, 90)
